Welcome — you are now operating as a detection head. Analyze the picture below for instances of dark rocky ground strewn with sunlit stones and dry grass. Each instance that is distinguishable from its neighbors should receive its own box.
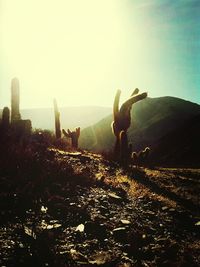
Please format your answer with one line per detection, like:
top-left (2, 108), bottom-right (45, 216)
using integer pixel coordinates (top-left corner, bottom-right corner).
top-left (0, 149), bottom-right (200, 267)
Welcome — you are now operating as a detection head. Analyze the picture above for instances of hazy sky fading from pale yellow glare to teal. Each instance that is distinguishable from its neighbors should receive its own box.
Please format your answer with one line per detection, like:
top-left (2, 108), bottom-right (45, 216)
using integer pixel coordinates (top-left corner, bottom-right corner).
top-left (0, 0), bottom-right (200, 108)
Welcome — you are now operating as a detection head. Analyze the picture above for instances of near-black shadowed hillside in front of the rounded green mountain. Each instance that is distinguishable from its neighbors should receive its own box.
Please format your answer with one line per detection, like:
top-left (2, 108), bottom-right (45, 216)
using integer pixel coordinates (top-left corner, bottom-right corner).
top-left (151, 115), bottom-right (200, 167)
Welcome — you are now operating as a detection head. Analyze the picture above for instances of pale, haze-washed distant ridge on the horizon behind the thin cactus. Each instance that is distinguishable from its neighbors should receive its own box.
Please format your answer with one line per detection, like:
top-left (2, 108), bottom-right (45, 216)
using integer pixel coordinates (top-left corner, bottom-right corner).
top-left (1, 106), bottom-right (112, 130)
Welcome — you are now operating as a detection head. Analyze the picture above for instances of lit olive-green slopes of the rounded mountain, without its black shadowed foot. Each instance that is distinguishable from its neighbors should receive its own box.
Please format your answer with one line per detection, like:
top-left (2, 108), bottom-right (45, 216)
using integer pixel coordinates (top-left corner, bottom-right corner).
top-left (80, 96), bottom-right (200, 166)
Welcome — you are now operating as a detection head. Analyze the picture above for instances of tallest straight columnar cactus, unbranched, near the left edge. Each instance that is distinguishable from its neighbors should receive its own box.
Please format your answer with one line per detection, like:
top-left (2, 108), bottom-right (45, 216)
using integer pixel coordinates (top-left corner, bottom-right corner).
top-left (11, 78), bottom-right (21, 122)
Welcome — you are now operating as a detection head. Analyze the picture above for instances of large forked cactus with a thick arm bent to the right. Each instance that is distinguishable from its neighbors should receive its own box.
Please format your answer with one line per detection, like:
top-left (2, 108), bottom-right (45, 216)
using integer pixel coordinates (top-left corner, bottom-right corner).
top-left (112, 88), bottom-right (147, 162)
